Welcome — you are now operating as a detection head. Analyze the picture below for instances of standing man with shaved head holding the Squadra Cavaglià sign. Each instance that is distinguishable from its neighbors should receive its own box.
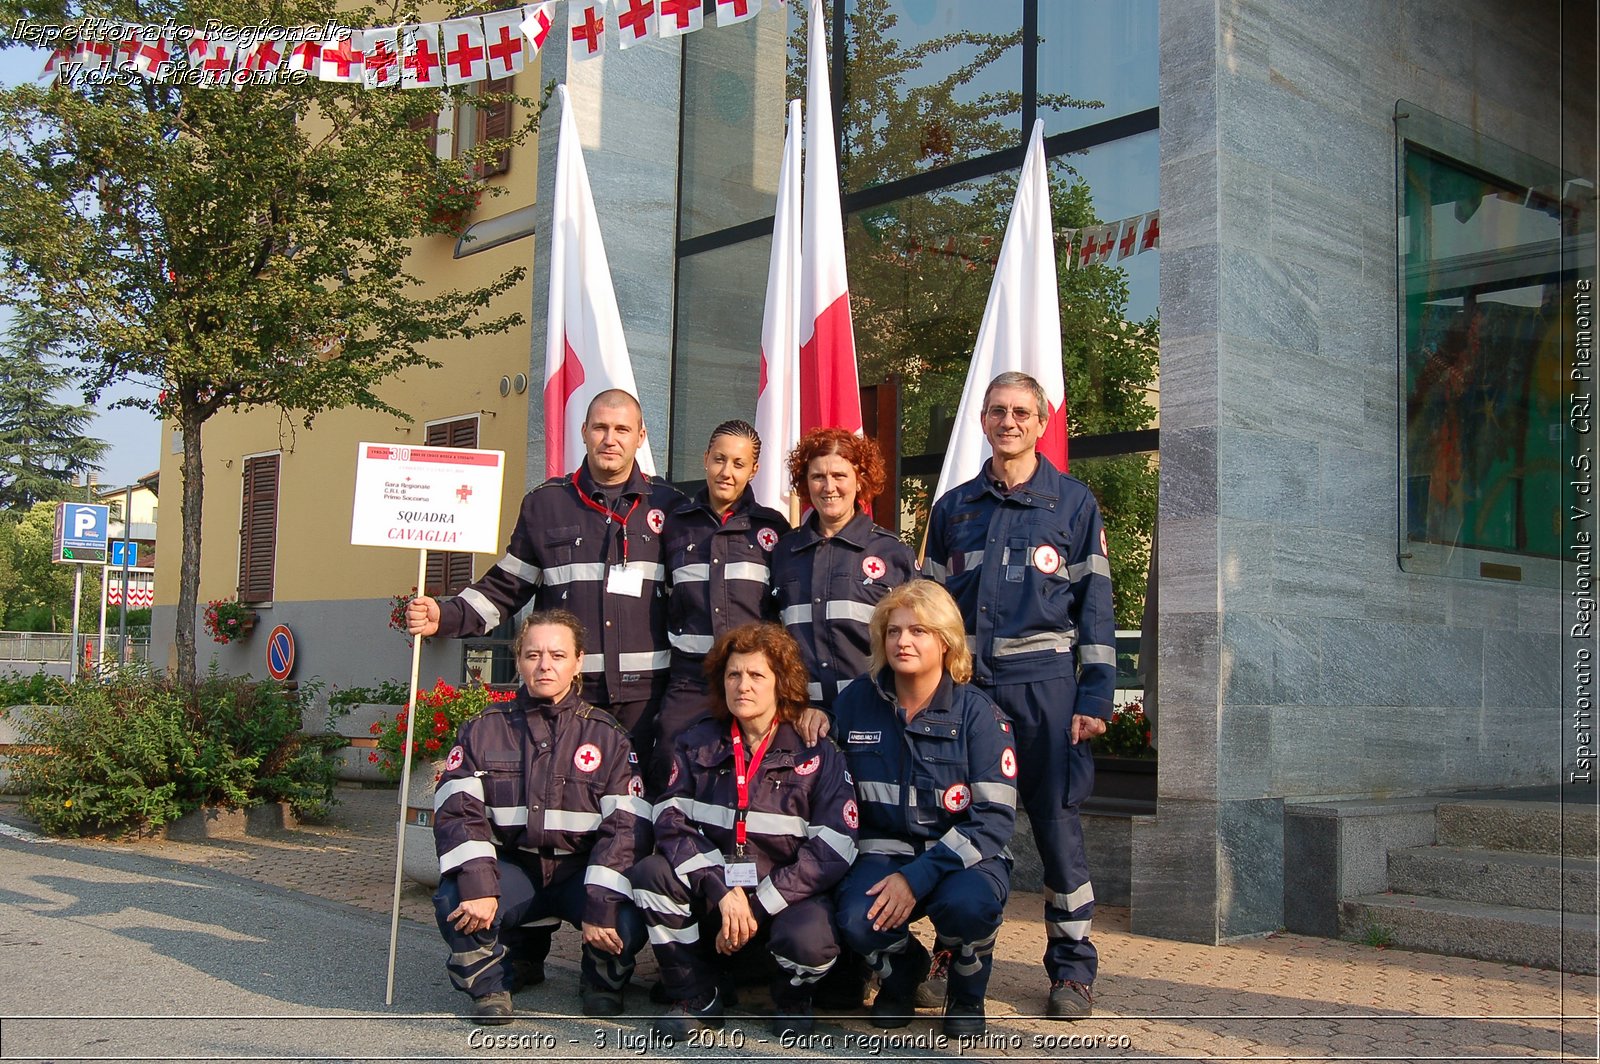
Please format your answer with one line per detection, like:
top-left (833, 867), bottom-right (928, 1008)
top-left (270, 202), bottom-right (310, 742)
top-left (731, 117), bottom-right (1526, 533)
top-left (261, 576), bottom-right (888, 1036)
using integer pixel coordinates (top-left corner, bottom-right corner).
top-left (406, 389), bottom-right (685, 780)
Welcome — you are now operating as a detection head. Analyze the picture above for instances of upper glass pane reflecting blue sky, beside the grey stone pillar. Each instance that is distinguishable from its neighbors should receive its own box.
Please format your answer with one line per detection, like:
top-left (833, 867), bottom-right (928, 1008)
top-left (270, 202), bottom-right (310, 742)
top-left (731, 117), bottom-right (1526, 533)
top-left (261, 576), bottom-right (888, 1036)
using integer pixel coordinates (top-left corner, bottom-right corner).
top-left (1038, 0), bottom-right (1160, 133)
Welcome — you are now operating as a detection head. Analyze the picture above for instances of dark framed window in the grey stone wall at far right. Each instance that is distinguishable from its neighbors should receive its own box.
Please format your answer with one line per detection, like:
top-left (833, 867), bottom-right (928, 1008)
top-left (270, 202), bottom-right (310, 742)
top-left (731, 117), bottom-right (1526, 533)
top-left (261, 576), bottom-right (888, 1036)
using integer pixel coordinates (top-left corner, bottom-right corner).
top-left (1400, 106), bottom-right (1594, 582)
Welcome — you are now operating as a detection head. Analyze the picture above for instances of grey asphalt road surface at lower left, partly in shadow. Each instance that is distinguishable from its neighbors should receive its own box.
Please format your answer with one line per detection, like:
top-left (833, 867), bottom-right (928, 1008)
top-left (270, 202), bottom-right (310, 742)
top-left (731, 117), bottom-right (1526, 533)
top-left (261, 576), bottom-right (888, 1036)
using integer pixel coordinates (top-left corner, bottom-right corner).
top-left (0, 834), bottom-right (837, 1061)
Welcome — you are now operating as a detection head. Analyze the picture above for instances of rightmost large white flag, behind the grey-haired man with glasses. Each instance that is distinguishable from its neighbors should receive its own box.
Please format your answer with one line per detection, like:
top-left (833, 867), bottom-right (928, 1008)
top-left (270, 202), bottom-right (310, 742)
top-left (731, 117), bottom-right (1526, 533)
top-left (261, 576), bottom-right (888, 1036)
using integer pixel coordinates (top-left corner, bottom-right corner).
top-left (933, 122), bottom-right (1067, 499)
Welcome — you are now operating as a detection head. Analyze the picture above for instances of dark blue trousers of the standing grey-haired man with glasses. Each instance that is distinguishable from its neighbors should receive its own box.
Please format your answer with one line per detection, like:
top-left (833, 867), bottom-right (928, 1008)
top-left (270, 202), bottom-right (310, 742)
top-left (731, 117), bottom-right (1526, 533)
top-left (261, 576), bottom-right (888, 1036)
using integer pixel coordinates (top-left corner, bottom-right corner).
top-left (982, 678), bottom-right (1099, 984)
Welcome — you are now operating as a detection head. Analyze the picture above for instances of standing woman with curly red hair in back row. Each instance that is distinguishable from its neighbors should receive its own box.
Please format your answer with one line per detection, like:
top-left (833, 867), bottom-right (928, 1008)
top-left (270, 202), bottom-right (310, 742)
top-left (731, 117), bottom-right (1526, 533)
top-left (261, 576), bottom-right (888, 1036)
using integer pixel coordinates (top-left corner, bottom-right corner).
top-left (773, 429), bottom-right (917, 716)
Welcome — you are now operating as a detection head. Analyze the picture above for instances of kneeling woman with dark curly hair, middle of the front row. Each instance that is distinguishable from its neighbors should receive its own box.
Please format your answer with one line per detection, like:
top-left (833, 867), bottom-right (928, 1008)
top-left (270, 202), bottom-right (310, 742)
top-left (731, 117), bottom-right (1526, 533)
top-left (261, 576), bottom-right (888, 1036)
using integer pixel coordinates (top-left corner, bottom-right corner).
top-left (629, 624), bottom-right (856, 1038)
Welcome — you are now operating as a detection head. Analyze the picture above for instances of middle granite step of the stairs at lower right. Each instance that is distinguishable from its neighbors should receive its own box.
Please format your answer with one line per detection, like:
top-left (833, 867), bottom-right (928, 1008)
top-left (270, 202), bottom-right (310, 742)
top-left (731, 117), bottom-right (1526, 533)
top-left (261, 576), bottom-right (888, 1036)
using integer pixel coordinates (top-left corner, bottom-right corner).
top-left (1389, 846), bottom-right (1600, 914)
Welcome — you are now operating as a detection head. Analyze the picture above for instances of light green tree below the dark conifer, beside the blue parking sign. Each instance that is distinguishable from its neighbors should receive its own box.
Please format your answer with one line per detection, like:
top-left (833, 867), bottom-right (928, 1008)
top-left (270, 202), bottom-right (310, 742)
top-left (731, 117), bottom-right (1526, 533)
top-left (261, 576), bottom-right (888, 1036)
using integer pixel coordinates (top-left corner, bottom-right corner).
top-left (0, 502), bottom-right (101, 632)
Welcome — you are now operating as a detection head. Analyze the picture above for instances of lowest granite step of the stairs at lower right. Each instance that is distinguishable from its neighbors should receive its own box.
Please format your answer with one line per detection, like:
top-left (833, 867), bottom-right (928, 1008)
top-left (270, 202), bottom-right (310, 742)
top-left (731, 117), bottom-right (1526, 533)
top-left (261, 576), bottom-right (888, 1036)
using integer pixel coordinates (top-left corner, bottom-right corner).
top-left (1339, 894), bottom-right (1600, 976)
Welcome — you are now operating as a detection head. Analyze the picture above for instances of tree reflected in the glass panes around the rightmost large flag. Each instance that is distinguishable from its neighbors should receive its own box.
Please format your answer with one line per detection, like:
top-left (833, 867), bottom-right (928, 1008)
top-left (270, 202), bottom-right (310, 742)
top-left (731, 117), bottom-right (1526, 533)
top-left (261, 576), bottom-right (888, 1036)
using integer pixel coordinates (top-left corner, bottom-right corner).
top-left (789, 0), bottom-right (1158, 627)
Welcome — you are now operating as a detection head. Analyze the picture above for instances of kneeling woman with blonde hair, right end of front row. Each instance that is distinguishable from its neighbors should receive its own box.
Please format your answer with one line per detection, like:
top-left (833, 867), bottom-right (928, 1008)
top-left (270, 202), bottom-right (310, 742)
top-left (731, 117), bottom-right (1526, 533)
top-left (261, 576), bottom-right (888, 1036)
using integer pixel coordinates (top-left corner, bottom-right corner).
top-left (834, 581), bottom-right (1016, 1035)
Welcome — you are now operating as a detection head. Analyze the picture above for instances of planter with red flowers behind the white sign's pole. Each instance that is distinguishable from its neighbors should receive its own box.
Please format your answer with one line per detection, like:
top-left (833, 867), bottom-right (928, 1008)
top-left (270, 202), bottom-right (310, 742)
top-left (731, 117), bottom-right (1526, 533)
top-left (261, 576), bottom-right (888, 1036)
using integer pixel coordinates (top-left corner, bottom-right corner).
top-left (368, 680), bottom-right (515, 886)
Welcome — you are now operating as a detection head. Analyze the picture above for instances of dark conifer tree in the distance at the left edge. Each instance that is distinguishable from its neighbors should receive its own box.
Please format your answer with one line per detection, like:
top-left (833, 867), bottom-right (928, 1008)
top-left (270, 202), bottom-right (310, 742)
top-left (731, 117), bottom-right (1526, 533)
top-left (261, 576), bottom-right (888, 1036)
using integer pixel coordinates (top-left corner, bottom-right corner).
top-left (0, 315), bottom-right (109, 520)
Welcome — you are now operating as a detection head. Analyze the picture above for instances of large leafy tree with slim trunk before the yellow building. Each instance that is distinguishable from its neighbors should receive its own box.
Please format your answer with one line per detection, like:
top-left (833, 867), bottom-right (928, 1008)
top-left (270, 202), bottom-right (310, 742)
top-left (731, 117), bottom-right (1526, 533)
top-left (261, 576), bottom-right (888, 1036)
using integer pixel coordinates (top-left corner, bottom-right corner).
top-left (0, 0), bottom-right (538, 683)
